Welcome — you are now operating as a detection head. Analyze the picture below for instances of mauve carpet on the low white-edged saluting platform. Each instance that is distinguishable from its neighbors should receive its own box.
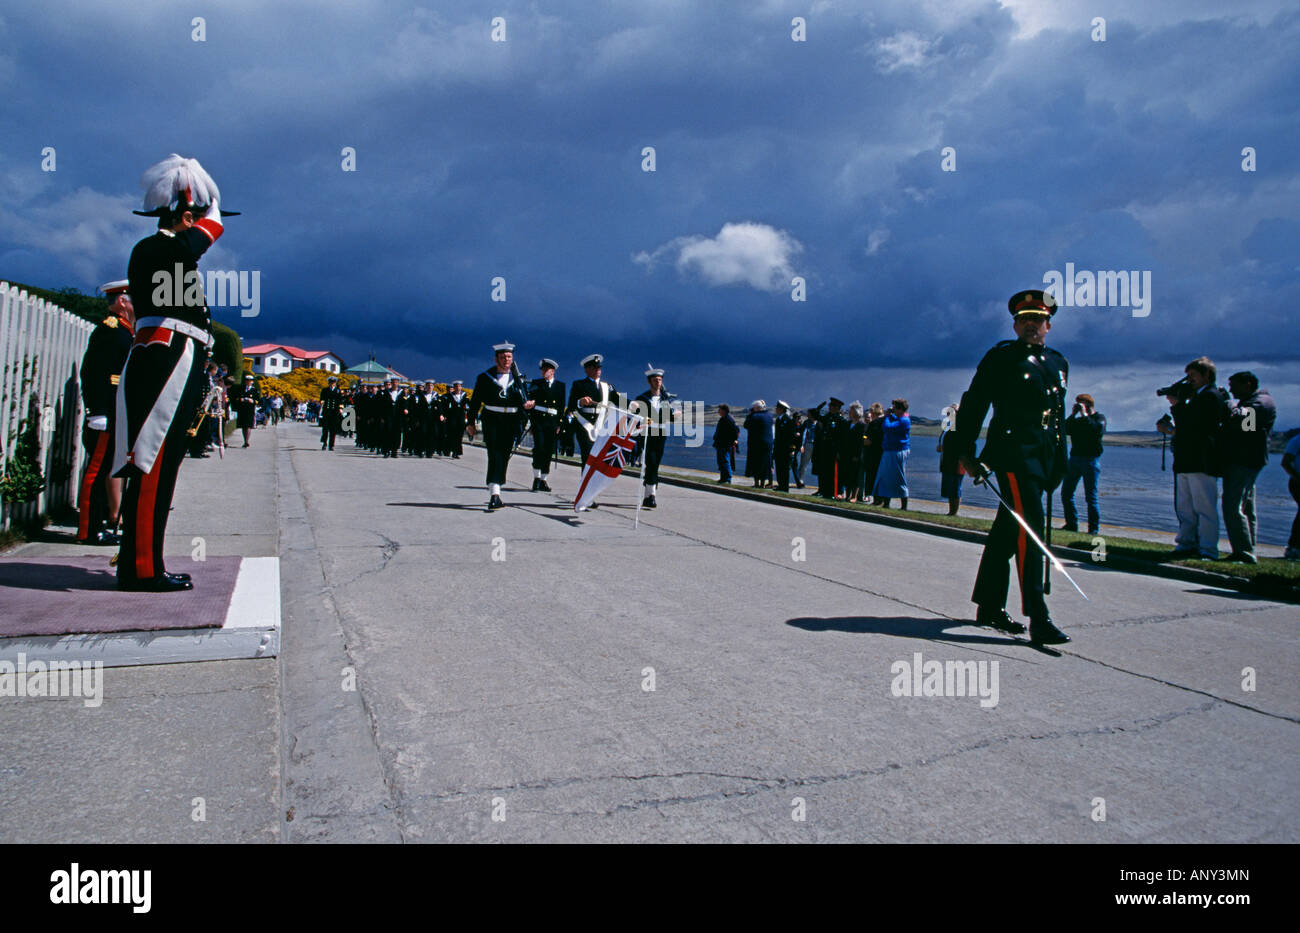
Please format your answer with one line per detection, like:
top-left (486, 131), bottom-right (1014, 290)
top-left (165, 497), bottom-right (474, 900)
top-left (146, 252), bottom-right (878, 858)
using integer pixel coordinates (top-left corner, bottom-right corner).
top-left (0, 558), bottom-right (242, 638)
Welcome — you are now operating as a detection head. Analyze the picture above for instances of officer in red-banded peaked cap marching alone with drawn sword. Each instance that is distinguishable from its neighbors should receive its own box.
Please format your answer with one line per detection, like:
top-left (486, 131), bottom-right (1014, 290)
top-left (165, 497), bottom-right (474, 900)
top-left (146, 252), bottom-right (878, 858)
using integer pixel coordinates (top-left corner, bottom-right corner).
top-left (953, 290), bottom-right (1070, 645)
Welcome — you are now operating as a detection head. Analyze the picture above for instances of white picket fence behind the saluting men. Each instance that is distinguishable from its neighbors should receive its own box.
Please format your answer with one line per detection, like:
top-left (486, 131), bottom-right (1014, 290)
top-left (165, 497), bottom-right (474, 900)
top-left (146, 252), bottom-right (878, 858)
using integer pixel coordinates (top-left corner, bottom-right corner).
top-left (0, 282), bottom-right (95, 529)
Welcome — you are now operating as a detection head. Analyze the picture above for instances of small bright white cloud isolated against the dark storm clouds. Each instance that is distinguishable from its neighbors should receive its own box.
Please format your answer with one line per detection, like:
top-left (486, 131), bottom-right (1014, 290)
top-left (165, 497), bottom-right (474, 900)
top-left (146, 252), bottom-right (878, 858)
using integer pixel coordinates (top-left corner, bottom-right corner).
top-left (632, 222), bottom-right (803, 291)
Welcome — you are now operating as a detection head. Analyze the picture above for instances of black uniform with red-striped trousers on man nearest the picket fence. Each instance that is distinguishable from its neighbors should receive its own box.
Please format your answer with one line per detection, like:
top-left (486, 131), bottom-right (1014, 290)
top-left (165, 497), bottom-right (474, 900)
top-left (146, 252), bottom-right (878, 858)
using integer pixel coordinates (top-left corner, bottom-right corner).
top-left (77, 314), bottom-right (133, 544)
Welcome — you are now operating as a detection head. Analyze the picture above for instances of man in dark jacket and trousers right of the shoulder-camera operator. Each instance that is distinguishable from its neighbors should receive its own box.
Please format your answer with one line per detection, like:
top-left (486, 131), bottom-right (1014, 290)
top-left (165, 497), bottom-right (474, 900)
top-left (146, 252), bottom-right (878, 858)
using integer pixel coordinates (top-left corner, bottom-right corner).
top-left (1221, 372), bottom-right (1278, 564)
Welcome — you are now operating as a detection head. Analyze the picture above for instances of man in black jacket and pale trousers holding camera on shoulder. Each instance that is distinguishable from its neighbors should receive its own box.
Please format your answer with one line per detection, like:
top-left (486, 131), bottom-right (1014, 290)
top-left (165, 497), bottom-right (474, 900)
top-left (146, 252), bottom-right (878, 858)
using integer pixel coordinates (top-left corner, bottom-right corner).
top-left (1156, 356), bottom-right (1227, 560)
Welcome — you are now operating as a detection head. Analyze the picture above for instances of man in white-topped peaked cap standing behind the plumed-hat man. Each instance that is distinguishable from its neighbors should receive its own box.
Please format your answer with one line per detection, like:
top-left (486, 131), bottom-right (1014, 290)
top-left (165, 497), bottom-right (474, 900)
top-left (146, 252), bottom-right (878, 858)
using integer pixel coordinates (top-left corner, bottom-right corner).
top-left (77, 278), bottom-right (135, 544)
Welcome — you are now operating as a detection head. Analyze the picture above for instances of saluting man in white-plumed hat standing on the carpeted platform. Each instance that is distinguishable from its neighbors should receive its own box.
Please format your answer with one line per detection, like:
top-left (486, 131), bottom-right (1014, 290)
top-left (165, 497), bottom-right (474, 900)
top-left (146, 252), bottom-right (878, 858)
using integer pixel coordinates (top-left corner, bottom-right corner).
top-left (113, 153), bottom-right (236, 593)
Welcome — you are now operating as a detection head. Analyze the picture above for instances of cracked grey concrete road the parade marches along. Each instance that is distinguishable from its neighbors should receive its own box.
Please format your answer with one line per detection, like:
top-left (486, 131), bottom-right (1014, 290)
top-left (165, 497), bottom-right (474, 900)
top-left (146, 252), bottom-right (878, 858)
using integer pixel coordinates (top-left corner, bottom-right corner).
top-left (278, 428), bottom-right (1300, 842)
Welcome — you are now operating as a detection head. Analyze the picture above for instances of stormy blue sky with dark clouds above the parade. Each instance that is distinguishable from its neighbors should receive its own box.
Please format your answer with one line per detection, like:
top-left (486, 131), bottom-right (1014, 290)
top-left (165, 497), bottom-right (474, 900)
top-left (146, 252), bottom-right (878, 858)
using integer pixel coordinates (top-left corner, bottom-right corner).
top-left (0, 0), bottom-right (1300, 428)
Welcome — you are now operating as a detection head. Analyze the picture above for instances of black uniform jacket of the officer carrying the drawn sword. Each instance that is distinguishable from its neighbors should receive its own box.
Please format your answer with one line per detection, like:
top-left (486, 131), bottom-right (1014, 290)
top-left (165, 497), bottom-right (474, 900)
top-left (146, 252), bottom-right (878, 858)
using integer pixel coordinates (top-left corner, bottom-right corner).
top-left (944, 340), bottom-right (1070, 489)
